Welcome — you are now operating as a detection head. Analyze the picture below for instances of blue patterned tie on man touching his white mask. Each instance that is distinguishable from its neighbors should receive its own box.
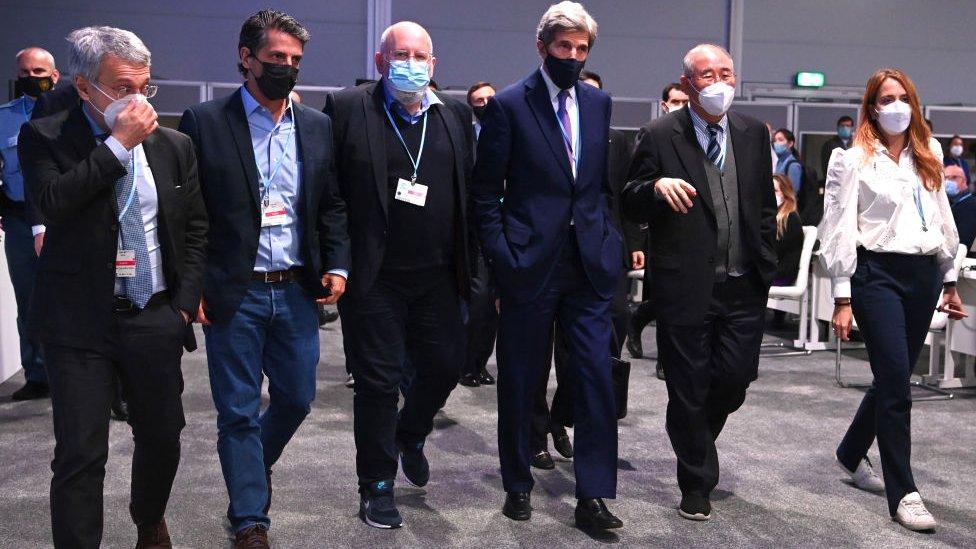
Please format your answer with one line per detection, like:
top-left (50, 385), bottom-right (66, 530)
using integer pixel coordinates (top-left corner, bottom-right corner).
top-left (115, 155), bottom-right (153, 309)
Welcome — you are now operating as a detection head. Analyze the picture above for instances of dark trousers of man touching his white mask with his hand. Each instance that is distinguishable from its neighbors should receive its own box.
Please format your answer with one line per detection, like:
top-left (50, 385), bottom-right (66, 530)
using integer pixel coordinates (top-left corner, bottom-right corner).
top-left (44, 298), bottom-right (186, 549)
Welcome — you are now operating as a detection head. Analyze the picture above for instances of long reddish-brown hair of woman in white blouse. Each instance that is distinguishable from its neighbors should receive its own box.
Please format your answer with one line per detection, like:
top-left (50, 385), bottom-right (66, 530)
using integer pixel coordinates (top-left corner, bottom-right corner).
top-left (854, 68), bottom-right (942, 191)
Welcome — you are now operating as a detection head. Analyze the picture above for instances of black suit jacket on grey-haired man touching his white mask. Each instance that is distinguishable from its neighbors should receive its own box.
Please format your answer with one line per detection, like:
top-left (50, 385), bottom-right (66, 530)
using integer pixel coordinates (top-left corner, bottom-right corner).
top-left (17, 106), bottom-right (207, 350)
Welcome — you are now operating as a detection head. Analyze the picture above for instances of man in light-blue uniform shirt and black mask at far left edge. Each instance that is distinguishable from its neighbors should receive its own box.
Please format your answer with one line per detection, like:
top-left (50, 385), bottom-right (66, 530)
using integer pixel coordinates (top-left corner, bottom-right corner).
top-left (0, 47), bottom-right (61, 401)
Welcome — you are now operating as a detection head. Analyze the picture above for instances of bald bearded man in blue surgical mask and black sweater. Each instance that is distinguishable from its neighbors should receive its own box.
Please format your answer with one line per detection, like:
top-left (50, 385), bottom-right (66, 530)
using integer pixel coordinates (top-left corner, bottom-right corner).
top-left (325, 21), bottom-right (472, 528)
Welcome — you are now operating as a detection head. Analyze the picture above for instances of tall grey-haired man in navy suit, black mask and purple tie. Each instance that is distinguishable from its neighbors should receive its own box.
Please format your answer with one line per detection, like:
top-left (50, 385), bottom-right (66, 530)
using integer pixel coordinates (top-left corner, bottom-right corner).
top-left (471, 2), bottom-right (623, 530)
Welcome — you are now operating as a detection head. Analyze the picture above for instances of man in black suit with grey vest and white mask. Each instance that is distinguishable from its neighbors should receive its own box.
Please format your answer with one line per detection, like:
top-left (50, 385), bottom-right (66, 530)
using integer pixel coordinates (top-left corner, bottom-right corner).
top-left (623, 44), bottom-right (776, 520)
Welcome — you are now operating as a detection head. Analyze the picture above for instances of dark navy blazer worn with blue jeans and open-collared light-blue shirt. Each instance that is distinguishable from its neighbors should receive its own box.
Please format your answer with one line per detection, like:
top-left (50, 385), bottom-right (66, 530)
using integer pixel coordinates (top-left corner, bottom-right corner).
top-left (180, 90), bottom-right (349, 322)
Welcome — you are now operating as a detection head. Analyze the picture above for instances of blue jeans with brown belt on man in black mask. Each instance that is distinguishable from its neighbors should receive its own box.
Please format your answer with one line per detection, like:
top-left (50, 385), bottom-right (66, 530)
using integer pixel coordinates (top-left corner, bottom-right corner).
top-left (203, 282), bottom-right (319, 531)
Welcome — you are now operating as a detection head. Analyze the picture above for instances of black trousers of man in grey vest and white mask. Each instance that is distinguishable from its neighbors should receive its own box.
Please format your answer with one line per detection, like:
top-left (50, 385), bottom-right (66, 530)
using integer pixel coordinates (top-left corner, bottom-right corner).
top-left (657, 274), bottom-right (768, 497)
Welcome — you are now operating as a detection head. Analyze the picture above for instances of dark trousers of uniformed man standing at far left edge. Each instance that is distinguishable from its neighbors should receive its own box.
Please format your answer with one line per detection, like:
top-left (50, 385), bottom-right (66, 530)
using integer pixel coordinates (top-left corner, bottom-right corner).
top-left (3, 212), bottom-right (47, 383)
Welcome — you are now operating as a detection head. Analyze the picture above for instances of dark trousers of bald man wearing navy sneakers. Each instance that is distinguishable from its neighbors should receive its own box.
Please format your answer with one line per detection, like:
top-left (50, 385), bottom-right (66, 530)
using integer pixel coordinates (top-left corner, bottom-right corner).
top-left (340, 267), bottom-right (464, 487)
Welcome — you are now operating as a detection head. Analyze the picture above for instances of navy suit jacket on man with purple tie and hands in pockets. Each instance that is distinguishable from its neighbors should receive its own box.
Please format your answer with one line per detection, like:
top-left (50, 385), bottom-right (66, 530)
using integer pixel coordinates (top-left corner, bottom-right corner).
top-left (471, 70), bottom-right (624, 301)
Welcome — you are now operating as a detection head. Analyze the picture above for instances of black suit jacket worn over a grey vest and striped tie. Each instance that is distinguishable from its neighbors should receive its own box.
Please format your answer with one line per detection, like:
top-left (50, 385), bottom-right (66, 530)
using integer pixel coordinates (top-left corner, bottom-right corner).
top-left (623, 107), bottom-right (777, 325)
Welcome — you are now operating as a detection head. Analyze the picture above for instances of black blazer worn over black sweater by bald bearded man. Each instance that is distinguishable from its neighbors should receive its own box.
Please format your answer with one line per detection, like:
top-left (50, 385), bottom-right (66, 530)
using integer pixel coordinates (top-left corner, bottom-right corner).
top-left (325, 82), bottom-right (474, 299)
